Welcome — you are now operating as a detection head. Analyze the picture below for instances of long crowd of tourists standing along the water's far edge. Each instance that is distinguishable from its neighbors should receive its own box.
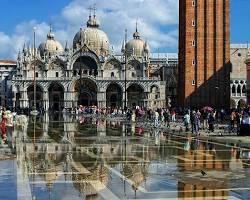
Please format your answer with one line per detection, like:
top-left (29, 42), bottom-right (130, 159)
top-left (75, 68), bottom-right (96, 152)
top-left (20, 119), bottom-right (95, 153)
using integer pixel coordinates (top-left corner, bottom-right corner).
top-left (65, 106), bottom-right (250, 134)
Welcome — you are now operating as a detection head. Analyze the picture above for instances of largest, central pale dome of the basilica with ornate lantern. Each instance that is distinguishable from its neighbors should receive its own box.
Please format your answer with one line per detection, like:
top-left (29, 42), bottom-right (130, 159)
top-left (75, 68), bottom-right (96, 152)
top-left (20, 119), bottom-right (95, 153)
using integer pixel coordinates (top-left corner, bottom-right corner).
top-left (73, 15), bottom-right (109, 55)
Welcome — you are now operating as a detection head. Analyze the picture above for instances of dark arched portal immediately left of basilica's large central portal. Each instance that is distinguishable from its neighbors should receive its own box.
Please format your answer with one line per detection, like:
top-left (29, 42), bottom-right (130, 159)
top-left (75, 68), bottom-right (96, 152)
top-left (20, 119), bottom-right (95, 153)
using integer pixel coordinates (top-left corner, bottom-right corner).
top-left (49, 83), bottom-right (64, 111)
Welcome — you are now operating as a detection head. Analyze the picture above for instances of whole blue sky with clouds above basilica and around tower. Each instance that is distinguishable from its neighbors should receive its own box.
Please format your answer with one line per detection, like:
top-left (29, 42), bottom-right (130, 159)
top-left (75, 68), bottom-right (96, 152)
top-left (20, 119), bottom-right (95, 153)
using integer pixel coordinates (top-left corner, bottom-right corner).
top-left (0, 0), bottom-right (250, 58)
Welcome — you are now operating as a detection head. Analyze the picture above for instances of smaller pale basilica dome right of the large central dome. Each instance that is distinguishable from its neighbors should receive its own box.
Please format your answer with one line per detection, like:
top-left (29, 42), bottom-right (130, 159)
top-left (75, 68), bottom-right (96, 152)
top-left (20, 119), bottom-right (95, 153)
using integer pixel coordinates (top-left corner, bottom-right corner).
top-left (125, 27), bottom-right (150, 58)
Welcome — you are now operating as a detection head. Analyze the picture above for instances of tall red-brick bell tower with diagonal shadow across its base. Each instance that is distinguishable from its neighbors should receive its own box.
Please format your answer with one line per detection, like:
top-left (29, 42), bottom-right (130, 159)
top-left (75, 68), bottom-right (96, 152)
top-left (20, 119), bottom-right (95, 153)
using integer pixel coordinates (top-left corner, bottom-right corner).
top-left (178, 0), bottom-right (231, 108)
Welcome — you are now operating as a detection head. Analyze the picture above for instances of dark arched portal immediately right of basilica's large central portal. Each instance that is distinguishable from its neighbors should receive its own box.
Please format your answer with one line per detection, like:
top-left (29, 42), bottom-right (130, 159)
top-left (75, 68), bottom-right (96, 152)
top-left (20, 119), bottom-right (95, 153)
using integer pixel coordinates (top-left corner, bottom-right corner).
top-left (106, 83), bottom-right (122, 108)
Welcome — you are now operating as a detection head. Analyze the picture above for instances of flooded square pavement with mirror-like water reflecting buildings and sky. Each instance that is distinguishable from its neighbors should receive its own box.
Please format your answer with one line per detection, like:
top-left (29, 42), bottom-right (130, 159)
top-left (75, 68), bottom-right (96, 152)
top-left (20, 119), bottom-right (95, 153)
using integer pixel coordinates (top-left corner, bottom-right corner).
top-left (0, 115), bottom-right (250, 200)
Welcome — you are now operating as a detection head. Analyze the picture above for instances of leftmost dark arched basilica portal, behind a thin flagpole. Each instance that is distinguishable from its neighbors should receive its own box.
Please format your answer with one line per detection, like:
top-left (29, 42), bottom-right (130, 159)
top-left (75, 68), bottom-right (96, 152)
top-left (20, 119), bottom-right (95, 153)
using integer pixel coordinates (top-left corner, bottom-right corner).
top-left (27, 85), bottom-right (43, 109)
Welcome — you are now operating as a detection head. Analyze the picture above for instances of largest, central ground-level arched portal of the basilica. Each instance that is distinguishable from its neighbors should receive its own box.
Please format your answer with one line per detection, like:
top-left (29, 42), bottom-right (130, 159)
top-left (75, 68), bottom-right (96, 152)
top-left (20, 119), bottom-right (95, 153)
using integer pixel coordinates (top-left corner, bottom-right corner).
top-left (75, 79), bottom-right (97, 106)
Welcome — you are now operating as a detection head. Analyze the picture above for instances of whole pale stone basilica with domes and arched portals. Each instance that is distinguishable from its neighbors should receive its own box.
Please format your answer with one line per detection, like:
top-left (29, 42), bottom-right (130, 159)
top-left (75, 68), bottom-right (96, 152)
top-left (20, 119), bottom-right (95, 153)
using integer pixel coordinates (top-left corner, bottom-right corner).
top-left (12, 15), bottom-right (166, 110)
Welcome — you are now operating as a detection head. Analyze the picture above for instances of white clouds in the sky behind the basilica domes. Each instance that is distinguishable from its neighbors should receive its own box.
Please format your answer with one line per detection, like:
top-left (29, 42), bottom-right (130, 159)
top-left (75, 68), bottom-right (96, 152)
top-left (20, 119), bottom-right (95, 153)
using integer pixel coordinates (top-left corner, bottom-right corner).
top-left (0, 0), bottom-right (178, 58)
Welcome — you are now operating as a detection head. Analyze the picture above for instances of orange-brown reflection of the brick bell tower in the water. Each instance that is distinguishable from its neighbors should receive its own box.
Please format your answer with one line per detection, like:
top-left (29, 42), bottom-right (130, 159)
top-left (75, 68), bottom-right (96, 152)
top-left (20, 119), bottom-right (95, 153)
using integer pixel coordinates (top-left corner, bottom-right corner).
top-left (177, 137), bottom-right (230, 199)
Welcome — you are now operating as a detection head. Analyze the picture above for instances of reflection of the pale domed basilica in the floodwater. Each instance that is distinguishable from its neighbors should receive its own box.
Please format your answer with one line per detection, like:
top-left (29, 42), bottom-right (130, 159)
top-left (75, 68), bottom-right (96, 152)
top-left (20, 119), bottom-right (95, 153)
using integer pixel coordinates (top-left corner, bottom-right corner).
top-left (13, 114), bottom-right (154, 199)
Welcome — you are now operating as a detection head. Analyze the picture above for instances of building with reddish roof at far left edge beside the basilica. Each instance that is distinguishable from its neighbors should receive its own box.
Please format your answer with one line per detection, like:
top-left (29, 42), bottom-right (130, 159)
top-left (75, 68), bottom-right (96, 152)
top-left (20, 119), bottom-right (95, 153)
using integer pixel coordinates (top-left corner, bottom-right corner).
top-left (0, 60), bottom-right (16, 106)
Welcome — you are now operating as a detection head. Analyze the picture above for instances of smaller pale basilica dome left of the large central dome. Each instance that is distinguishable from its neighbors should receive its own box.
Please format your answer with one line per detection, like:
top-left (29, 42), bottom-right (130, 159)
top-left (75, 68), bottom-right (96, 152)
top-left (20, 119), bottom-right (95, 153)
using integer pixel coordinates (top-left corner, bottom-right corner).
top-left (38, 30), bottom-right (63, 56)
